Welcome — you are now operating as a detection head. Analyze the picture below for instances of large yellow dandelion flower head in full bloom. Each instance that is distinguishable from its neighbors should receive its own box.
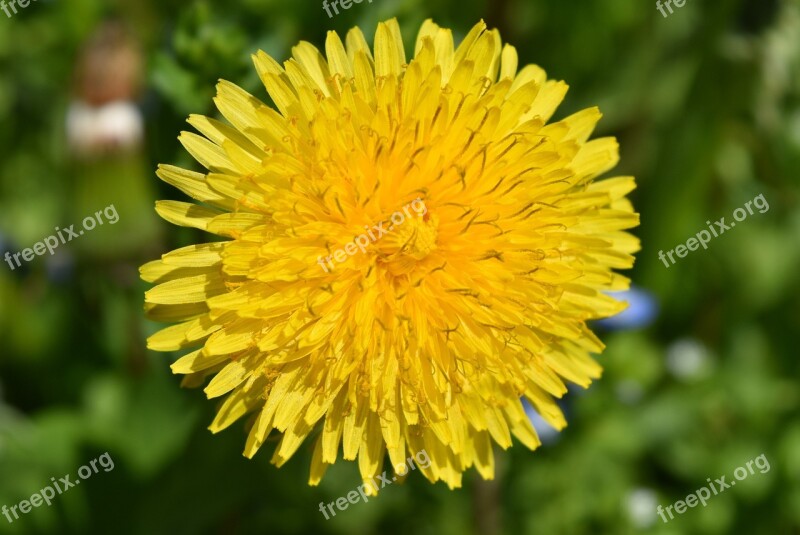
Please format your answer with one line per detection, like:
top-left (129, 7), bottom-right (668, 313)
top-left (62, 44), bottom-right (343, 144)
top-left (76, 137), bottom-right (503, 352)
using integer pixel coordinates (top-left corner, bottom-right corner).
top-left (141, 20), bottom-right (639, 488)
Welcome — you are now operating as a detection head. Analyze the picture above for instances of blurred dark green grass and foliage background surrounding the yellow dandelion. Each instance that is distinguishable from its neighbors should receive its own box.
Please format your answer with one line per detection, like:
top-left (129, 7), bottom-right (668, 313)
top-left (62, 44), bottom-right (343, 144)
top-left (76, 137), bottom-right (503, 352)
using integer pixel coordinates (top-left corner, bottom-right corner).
top-left (0, 0), bottom-right (800, 535)
